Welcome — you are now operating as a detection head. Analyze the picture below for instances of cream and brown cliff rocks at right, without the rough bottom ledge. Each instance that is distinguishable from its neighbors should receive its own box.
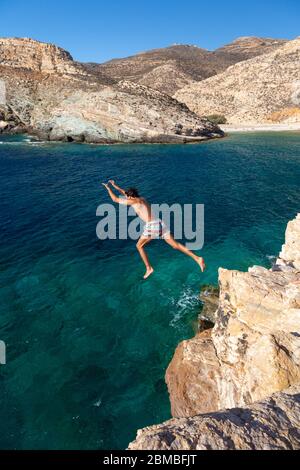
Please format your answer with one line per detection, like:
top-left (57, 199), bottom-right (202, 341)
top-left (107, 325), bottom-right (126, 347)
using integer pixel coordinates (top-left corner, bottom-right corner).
top-left (166, 215), bottom-right (300, 416)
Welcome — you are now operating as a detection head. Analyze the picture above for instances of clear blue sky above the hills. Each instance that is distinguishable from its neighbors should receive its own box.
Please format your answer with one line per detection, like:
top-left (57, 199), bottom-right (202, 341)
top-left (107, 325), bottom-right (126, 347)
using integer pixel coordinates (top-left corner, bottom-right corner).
top-left (0, 0), bottom-right (300, 62)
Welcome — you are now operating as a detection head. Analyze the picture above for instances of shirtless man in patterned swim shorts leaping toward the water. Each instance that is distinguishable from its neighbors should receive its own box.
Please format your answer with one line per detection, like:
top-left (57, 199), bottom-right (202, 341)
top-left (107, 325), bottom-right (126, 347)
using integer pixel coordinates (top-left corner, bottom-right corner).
top-left (102, 180), bottom-right (206, 279)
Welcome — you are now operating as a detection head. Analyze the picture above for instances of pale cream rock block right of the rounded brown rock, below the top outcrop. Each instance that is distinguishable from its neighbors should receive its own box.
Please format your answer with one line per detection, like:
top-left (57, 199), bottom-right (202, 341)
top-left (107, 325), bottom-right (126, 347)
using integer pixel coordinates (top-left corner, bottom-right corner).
top-left (212, 267), bottom-right (300, 408)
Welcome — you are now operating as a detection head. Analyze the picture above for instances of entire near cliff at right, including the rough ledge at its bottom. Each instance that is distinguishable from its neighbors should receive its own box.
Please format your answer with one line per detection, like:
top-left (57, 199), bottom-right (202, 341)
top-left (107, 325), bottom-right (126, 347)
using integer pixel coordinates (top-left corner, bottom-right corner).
top-left (129, 214), bottom-right (300, 450)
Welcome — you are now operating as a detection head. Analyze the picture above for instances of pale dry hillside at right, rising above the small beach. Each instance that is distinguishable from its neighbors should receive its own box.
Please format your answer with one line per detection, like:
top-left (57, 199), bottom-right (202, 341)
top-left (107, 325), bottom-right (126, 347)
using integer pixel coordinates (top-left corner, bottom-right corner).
top-left (175, 38), bottom-right (300, 124)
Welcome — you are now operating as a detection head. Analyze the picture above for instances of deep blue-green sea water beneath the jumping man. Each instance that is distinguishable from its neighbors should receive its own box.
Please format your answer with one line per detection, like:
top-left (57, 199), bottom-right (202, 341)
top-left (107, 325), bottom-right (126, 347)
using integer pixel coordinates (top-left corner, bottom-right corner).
top-left (0, 133), bottom-right (300, 449)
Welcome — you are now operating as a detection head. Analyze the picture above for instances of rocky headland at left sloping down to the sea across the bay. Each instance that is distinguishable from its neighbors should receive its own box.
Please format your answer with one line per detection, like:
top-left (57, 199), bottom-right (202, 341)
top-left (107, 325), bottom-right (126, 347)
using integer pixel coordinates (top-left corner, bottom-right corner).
top-left (0, 38), bottom-right (223, 143)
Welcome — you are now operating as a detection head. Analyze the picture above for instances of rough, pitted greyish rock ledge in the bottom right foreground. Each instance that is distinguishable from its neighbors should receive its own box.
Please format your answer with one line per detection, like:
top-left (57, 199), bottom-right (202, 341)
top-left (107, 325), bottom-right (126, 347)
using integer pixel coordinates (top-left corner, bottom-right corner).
top-left (128, 385), bottom-right (300, 450)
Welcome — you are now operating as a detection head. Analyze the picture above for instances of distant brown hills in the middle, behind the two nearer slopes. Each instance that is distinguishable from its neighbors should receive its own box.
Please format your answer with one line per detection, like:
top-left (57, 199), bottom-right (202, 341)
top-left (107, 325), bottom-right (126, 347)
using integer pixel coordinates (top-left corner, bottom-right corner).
top-left (86, 37), bottom-right (286, 95)
